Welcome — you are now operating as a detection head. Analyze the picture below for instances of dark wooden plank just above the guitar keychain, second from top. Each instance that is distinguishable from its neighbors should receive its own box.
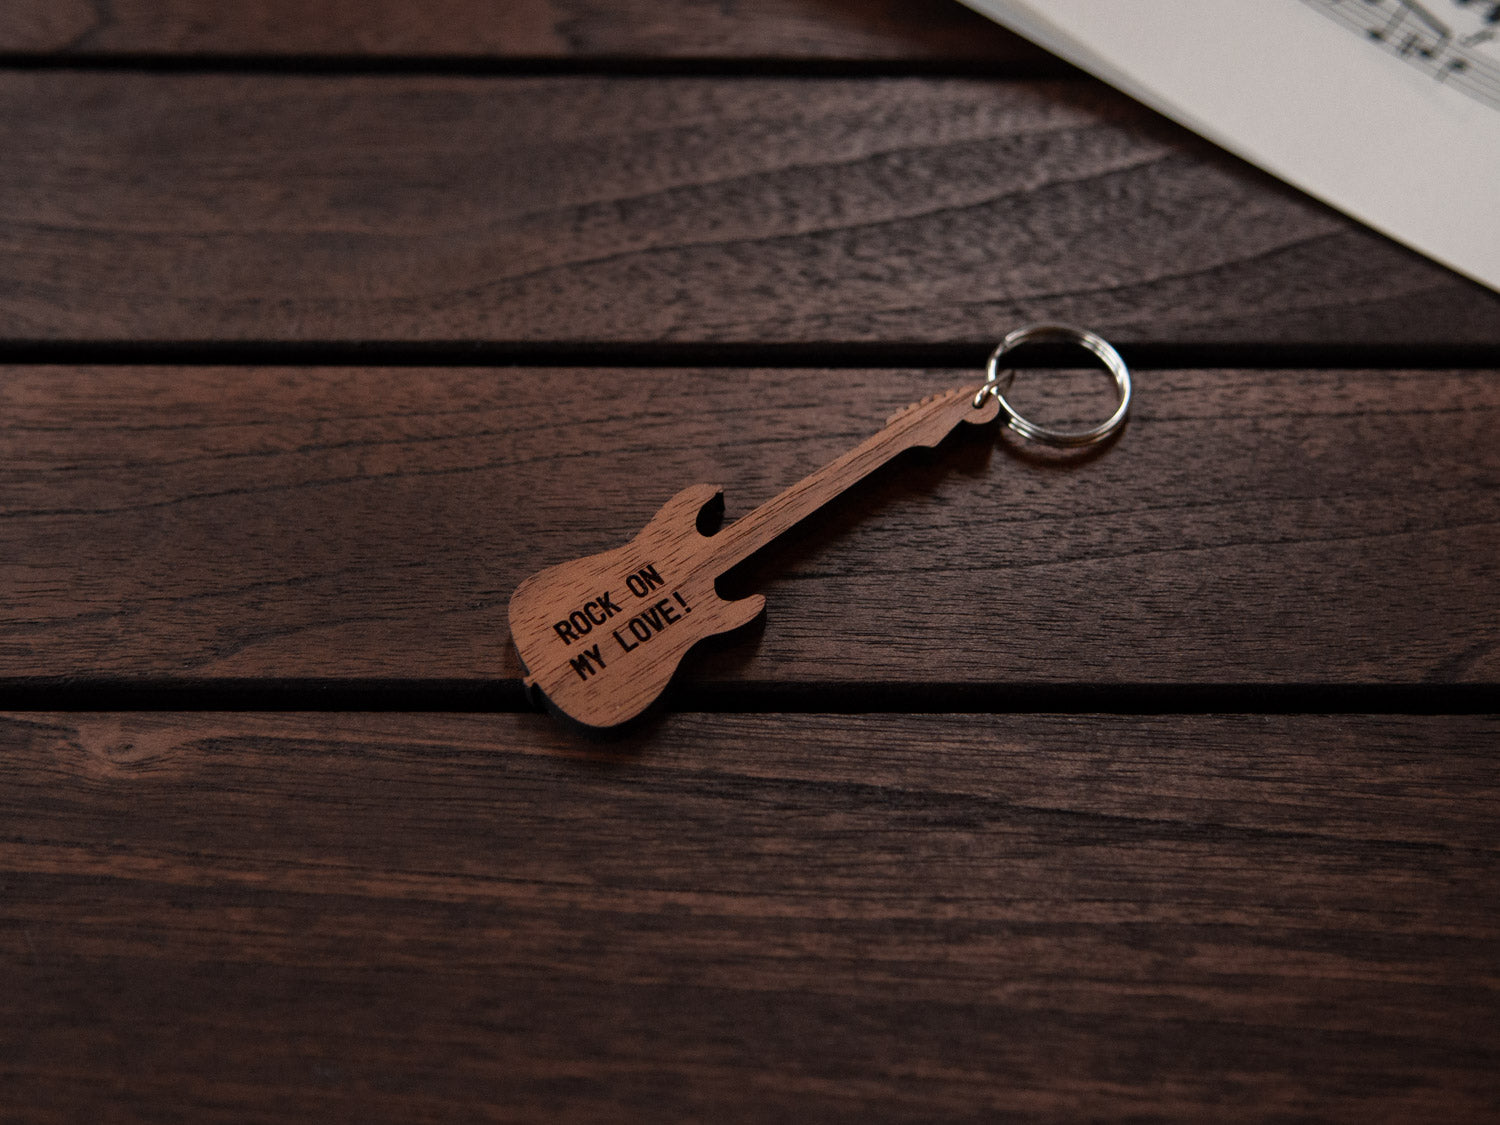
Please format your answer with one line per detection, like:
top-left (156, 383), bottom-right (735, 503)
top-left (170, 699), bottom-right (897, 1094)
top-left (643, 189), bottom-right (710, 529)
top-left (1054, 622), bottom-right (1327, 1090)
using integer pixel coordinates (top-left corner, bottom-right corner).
top-left (0, 72), bottom-right (1500, 348)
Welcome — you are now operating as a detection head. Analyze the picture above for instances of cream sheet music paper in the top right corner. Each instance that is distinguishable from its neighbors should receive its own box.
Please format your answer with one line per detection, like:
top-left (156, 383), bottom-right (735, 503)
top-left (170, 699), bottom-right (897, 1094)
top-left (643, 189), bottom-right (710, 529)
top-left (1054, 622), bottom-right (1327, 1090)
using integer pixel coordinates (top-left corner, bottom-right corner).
top-left (965, 0), bottom-right (1500, 290)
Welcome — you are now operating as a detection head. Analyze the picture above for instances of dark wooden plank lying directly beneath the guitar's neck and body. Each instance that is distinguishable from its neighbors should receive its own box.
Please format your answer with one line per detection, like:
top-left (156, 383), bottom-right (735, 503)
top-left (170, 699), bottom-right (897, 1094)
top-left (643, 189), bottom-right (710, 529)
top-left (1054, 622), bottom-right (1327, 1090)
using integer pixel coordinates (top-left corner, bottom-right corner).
top-left (0, 366), bottom-right (1500, 687)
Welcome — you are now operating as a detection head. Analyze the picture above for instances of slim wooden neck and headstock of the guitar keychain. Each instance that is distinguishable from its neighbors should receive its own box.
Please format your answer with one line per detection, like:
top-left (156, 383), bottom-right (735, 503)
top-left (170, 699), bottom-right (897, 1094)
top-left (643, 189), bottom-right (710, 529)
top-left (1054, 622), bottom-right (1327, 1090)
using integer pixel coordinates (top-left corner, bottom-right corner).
top-left (711, 387), bottom-right (998, 575)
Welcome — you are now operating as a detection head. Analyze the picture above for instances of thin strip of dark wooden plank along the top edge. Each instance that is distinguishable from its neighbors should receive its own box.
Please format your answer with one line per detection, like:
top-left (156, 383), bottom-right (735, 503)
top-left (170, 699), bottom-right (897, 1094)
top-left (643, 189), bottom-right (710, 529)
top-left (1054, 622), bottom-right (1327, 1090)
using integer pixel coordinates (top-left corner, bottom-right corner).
top-left (0, 0), bottom-right (1046, 63)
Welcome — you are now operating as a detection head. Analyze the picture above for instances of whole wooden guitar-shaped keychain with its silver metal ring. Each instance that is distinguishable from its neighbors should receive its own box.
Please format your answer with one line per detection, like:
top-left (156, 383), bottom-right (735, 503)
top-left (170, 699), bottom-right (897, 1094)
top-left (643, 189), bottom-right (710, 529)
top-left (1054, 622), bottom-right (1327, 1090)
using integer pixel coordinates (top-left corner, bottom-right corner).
top-left (510, 324), bottom-right (1131, 728)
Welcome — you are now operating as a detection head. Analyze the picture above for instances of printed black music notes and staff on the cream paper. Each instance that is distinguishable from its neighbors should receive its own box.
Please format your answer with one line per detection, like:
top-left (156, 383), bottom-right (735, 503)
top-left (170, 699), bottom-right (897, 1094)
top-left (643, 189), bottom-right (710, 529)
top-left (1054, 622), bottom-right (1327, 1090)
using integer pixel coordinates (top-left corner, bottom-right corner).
top-left (1302, 0), bottom-right (1500, 110)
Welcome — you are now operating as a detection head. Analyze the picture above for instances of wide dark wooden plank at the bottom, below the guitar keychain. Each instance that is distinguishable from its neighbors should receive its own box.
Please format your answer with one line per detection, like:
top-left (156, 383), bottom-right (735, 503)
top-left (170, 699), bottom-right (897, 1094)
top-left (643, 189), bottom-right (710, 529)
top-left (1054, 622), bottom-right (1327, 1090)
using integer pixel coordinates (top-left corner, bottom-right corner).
top-left (0, 714), bottom-right (1500, 1122)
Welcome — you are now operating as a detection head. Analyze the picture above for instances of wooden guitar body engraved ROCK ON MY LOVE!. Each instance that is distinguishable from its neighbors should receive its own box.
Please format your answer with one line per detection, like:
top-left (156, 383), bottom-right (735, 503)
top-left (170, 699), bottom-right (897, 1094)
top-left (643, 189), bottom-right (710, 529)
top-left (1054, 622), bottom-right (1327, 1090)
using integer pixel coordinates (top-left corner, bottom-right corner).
top-left (510, 485), bottom-right (765, 728)
